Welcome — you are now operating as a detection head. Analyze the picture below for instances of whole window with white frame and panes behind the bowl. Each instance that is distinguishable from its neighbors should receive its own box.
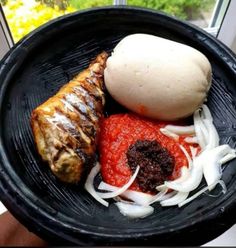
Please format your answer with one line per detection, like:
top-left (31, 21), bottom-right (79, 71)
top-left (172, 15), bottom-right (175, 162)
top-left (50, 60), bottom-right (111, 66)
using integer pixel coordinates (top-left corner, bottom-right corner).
top-left (0, 0), bottom-right (236, 57)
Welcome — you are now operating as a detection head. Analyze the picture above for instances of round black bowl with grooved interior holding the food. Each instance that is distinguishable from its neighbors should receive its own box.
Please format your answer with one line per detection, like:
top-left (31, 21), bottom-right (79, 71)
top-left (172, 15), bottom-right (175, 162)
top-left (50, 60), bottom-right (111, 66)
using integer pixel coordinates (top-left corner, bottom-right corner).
top-left (0, 7), bottom-right (236, 246)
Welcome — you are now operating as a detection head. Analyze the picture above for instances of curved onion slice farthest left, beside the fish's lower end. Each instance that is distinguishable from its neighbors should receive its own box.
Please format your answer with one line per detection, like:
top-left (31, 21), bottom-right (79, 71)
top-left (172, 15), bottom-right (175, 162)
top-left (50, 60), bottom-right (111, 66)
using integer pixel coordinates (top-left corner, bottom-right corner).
top-left (84, 163), bottom-right (109, 207)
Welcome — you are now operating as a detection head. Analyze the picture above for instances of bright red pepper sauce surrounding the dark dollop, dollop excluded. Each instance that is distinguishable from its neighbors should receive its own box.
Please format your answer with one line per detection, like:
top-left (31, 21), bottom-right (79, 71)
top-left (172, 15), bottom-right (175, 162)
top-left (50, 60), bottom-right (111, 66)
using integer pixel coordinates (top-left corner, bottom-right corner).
top-left (99, 114), bottom-right (199, 191)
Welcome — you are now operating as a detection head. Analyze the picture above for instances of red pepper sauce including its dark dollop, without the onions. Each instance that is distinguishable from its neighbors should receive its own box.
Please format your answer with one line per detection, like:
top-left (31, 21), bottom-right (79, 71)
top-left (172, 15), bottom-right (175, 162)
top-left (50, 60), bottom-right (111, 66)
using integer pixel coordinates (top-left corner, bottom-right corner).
top-left (99, 113), bottom-right (194, 193)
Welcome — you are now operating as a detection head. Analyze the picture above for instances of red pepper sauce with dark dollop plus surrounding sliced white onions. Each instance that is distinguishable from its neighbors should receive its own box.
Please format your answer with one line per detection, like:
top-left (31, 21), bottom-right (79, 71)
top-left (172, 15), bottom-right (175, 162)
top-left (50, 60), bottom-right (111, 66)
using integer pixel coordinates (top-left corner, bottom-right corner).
top-left (85, 105), bottom-right (236, 218)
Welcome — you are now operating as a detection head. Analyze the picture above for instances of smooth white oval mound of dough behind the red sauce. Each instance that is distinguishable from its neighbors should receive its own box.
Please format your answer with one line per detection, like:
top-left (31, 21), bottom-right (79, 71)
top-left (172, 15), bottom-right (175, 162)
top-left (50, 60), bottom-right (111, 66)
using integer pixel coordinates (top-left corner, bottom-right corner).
top-left (104, 34), bottom-right (211, 120)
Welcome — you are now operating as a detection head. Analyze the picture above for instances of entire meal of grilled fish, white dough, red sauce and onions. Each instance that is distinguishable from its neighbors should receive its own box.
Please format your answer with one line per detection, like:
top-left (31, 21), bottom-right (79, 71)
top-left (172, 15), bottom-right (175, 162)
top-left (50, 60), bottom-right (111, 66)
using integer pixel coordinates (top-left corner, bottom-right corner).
top-left (31, 34), bottom-right (236, 218)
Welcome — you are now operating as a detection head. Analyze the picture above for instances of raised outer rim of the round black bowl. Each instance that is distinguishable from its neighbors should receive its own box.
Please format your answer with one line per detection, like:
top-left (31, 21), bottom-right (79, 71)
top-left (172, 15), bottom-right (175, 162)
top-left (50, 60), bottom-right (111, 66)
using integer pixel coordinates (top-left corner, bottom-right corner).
top-left (0, 6), bottom-right (236, 244)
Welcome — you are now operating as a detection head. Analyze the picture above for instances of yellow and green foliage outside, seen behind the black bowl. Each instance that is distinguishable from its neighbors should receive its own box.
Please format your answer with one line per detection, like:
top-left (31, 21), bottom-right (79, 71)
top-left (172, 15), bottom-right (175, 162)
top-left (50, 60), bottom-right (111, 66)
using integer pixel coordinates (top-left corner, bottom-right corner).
top-left (0, 0), bottom-right (216, 41)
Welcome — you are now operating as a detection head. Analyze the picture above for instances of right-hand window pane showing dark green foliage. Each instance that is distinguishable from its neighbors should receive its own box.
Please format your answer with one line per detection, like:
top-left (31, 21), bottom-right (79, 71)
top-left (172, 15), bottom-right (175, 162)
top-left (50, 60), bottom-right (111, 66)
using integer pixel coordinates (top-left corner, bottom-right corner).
top-left (127, 0), bottom-right (217, 28)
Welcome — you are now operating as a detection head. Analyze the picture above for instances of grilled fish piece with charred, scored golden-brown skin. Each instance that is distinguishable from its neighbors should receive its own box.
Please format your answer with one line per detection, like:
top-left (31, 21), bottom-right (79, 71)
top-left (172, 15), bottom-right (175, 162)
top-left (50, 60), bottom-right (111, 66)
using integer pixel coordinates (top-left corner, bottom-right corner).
top-left (30, 52), bottom-right (108, 183)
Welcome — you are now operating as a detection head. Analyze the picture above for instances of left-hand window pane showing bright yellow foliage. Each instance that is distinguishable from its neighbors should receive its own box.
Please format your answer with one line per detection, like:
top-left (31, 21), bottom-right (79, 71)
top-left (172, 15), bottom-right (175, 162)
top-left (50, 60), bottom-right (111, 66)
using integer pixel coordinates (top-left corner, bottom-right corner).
top-left (0, 0), bottom-right (113, 42)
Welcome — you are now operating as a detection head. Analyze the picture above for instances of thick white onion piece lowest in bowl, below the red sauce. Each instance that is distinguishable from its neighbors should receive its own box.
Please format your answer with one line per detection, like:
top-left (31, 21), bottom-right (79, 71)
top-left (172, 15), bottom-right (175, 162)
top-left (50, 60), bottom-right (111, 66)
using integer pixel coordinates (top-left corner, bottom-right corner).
top-left (114, 202), bottom-right (154, 218)
